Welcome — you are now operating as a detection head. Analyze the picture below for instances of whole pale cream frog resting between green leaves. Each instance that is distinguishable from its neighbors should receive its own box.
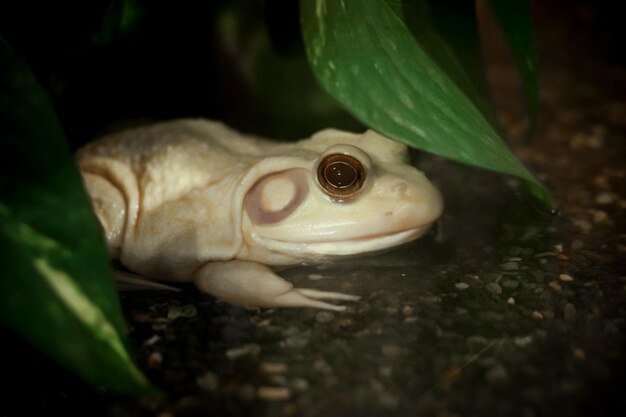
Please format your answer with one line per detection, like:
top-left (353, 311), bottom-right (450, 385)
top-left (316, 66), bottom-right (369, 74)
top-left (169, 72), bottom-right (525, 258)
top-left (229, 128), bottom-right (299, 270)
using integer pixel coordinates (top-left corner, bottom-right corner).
top-left (77, 120), bottom-right (443, 310)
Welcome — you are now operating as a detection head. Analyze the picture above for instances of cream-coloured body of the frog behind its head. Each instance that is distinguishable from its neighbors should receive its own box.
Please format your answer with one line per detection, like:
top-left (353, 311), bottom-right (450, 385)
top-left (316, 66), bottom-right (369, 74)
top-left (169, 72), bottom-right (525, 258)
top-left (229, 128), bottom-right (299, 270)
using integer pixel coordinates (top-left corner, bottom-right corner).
top-left (77, 120), bottom-right (268, 279)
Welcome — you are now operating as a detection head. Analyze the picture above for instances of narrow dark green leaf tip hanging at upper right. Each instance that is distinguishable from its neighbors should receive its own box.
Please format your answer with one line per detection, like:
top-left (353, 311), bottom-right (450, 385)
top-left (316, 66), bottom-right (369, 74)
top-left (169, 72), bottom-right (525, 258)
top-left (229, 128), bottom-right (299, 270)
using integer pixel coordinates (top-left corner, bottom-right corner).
top-left (488, 0), bottom-right (539, 139)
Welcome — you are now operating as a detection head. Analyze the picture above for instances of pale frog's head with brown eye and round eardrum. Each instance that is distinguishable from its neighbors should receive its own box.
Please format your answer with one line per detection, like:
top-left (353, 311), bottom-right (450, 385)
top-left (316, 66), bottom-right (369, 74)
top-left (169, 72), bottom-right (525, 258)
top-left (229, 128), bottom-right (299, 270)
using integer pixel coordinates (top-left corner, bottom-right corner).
top-left (236, 130), bottom-right (443, 259)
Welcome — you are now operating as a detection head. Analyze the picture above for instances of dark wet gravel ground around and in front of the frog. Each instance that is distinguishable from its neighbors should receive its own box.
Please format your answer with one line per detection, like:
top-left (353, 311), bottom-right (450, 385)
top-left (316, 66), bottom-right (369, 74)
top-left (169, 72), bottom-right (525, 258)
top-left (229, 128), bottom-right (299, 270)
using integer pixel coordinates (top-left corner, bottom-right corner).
top-left (2, 3), bottom-right (626, 417)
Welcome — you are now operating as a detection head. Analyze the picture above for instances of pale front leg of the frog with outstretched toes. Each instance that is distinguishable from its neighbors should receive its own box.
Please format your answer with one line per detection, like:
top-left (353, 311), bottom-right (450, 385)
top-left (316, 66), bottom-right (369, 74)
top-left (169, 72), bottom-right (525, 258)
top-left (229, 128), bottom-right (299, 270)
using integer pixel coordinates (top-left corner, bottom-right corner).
top-left (194, 261), bottom-right (360, 311)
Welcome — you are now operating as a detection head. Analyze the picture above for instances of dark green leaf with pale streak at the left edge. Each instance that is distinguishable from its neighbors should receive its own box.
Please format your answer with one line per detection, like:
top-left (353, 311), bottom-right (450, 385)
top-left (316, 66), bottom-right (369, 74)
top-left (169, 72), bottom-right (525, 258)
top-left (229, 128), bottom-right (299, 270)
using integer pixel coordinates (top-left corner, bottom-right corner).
top-left (0, 36), bottom-right (154, 394)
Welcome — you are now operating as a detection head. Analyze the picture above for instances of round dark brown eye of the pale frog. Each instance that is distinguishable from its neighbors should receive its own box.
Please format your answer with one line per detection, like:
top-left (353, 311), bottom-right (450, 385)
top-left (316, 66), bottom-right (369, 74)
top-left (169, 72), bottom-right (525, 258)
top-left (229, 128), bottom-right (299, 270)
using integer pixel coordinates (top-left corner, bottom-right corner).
top-left (317, 153), bottom-right (365, 200)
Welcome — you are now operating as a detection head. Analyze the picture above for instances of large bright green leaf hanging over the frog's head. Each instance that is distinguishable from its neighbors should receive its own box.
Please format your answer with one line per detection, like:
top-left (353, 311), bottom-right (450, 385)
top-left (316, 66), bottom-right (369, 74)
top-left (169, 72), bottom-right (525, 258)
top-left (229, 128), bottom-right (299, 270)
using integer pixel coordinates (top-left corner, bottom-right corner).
top-left (300, 0), bottom-right (552, 206)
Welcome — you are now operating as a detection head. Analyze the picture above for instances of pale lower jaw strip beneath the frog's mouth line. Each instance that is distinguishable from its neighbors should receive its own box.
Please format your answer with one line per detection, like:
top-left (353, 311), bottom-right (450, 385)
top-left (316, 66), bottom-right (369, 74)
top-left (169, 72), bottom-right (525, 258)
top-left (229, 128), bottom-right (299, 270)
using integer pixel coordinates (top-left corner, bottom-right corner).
top-left (258, 225), bottom-right (430, 258)
